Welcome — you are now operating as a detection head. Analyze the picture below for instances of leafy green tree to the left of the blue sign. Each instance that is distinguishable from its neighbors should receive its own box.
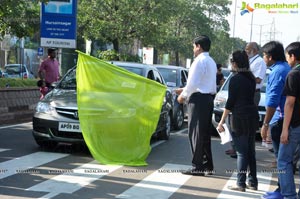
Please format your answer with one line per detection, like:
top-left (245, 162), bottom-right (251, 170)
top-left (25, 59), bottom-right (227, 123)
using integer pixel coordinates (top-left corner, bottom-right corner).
top-left (0, 0), bottom-right (48, 38)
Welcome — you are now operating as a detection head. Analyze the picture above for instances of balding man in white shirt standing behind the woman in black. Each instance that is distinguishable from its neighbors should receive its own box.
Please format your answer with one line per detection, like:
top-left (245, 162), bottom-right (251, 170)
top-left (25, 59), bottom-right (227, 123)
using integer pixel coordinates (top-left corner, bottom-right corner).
top-left (245, 42), bottom-right (267, 105)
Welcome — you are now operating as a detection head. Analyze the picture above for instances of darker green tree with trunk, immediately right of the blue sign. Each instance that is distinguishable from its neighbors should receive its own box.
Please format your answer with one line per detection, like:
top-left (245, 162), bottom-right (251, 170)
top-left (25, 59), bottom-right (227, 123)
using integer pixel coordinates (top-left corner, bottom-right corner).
top-left (78, 0), bottom-right (172, 52)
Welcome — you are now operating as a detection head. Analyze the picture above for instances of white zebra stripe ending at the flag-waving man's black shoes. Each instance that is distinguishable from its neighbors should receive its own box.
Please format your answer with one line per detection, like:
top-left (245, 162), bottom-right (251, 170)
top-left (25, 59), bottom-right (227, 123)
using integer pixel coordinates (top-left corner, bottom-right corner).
top-left (116, 164), bottom-right (192, 199)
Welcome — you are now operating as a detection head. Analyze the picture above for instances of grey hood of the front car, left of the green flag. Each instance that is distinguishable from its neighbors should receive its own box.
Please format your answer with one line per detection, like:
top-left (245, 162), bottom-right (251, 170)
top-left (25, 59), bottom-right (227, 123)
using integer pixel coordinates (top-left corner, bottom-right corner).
top-left (43, 89), bottom-right (77, 109)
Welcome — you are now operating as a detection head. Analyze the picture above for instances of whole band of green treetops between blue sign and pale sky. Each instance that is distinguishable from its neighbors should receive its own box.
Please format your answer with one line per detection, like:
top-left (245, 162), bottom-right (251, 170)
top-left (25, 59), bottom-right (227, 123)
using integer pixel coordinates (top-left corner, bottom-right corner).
top-left (78, 0), bottom-right (231, 65)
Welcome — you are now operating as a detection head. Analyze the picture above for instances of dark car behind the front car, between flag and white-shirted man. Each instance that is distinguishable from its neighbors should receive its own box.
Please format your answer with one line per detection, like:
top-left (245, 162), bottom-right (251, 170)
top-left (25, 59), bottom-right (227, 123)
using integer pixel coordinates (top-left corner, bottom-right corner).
top-left (155, 65), bottom-right (188, 130)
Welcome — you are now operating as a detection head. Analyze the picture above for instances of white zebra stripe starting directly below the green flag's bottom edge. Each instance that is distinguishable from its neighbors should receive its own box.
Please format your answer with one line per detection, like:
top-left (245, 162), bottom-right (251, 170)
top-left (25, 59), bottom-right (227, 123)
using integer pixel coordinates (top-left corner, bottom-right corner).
top-left (26, 161), bottom-right (122, 199)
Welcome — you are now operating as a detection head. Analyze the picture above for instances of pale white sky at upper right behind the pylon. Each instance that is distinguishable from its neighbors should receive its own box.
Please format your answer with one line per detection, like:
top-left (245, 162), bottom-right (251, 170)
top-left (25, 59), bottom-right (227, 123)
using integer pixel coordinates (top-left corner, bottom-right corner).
top-left (228, 0), bottom-right (300, 47)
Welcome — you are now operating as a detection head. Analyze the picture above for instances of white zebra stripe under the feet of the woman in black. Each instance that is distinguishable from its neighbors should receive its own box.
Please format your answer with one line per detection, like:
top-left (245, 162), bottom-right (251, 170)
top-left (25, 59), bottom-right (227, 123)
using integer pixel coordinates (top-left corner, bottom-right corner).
top-left (217, 172), bottom-right (272, 199)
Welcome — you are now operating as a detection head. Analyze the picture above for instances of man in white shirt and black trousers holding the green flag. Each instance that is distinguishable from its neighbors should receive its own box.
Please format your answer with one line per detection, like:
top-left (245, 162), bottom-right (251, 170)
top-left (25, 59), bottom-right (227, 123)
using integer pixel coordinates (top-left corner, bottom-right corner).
top-left (177, 35), bottom-right (217, 176)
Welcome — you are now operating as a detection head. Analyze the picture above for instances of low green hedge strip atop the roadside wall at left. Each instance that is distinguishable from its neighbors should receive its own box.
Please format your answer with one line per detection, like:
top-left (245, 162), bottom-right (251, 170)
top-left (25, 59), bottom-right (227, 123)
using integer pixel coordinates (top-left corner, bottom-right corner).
top-left (0, 78), bottom-right (37, 88)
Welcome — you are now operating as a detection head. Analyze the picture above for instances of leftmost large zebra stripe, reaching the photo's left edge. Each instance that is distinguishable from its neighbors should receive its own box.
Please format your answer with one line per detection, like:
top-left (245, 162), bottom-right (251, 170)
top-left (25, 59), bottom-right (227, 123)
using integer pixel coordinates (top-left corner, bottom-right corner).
top-left (0, 152), bottom-right (69, 179)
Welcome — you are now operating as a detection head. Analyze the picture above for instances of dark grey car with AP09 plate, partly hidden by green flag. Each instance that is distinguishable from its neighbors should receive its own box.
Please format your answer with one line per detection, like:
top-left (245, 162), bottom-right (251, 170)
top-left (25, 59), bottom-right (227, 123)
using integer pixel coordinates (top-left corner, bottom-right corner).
top-left (33, 62), bottom-right (172, 147)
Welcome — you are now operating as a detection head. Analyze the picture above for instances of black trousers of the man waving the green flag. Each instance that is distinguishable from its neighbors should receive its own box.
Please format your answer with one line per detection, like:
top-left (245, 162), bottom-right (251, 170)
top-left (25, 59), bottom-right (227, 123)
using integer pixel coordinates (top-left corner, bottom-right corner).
top-left (188, 93), bottom-right (213, 170)
